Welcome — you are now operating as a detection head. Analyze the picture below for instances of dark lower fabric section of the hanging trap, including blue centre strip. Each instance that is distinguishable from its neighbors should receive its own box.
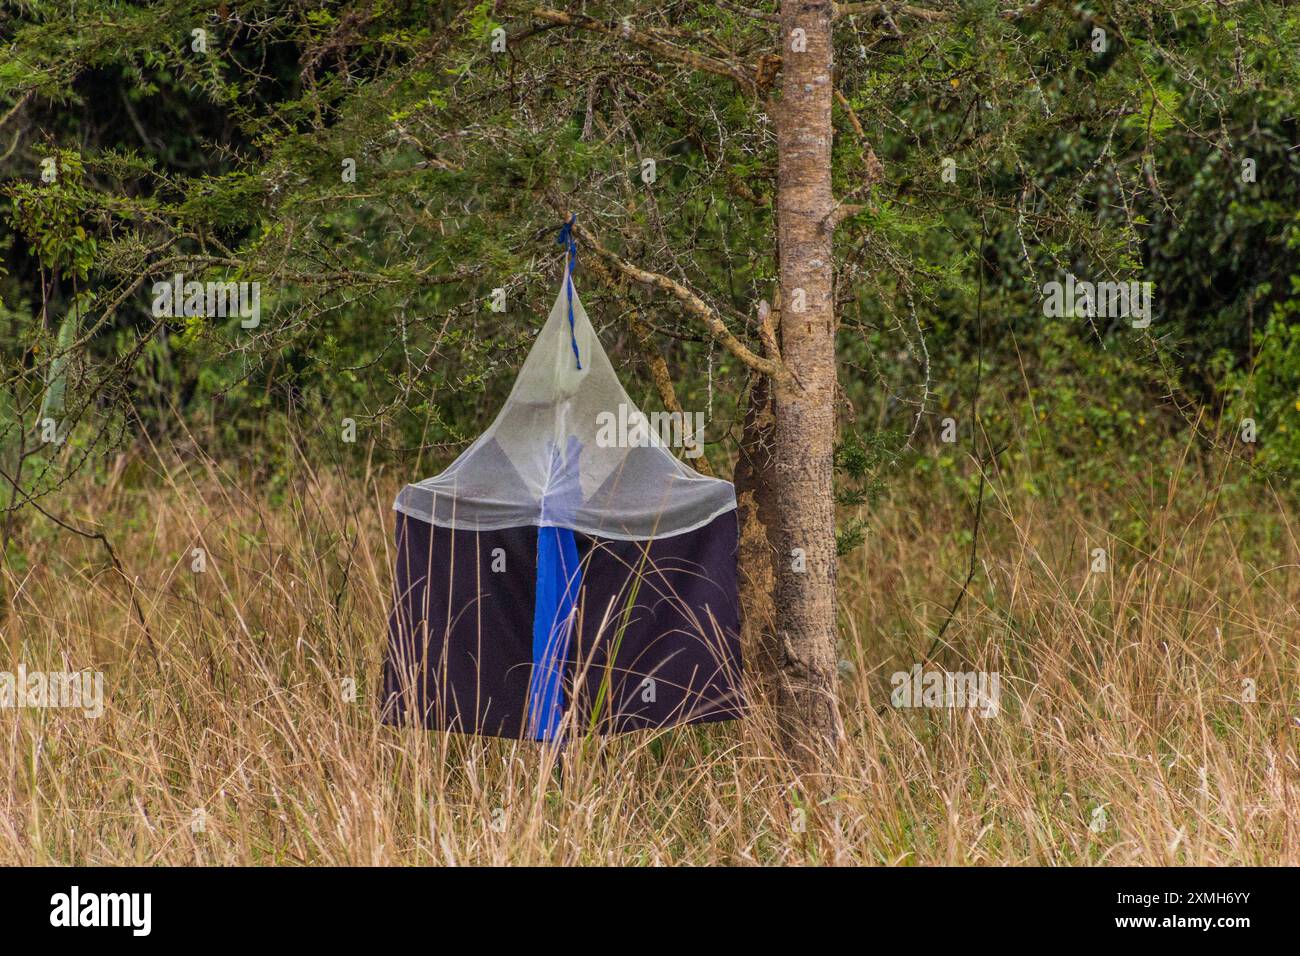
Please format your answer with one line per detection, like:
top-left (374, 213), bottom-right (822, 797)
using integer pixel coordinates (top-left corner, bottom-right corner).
top-left (384, 511), bottom-right (745, 739)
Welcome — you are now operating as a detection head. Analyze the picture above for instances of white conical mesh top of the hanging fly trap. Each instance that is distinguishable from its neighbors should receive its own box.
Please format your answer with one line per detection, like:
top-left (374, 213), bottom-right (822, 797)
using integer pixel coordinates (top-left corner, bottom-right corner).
top-left (394, 277), bottom-right (736, 540)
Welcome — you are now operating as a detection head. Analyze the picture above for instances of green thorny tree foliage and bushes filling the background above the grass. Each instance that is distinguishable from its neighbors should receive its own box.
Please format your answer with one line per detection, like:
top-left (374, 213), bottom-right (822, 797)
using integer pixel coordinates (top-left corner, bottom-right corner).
top-left (0, 0), bottom-right (1300, 509)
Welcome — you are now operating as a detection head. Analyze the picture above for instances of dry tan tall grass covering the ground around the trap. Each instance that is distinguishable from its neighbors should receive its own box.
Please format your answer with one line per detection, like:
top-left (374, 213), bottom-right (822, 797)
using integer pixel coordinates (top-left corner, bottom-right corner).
top-left (0, 442), bottom-right (1300, 865)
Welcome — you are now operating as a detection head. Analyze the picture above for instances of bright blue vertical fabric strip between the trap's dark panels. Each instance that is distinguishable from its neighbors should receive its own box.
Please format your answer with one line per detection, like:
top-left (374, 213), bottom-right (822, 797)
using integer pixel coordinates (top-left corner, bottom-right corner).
top-left (528, 528), bottom-right (582, 740)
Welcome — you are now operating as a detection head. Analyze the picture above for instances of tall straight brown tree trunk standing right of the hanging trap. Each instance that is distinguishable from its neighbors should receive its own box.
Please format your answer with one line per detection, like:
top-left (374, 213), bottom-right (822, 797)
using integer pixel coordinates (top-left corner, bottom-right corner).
top-left (767, 0), bottom-right (842, 763)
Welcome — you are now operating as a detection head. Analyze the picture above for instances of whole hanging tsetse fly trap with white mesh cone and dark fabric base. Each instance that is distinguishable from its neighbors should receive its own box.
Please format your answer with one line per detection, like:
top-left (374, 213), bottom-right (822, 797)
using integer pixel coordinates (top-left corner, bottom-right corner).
top-left (384, 224), bottom-right (744, 741)
